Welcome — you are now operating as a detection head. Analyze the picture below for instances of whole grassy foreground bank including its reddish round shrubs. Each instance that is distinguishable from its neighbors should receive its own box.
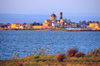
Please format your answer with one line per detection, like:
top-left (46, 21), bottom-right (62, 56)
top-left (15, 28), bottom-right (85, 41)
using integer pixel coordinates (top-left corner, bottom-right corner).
top-left (0, 48), bottom-right (100, 66)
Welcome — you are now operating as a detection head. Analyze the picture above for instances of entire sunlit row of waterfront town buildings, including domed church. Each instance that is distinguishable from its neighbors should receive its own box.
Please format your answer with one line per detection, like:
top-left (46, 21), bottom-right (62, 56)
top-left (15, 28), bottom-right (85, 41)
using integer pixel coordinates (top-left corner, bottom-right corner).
top-left (0, 12), bottom-right (100, 29)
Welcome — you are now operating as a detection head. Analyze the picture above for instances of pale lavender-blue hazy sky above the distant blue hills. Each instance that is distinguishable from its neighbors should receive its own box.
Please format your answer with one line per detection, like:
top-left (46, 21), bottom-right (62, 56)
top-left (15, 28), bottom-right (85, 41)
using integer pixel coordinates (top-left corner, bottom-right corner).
top-left (0, 0), bottom-right (100, 16)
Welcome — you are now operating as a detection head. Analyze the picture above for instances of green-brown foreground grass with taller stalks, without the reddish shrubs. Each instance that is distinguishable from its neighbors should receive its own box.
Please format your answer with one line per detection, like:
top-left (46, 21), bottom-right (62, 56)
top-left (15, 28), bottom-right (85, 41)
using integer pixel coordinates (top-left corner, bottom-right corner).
top-left (0, 48), bottom-right (100, 66)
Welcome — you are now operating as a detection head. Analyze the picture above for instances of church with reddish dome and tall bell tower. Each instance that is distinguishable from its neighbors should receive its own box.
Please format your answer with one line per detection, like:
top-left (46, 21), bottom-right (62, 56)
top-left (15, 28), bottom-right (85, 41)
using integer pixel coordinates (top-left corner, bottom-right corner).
top-left (43, 12), bottom-right (63, 27)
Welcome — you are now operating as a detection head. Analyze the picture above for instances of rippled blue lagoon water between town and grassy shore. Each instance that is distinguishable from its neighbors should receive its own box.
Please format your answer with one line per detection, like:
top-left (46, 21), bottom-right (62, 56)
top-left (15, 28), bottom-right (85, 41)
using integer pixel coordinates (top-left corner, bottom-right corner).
top-left (0, 30), bottom-right (100, 59)
